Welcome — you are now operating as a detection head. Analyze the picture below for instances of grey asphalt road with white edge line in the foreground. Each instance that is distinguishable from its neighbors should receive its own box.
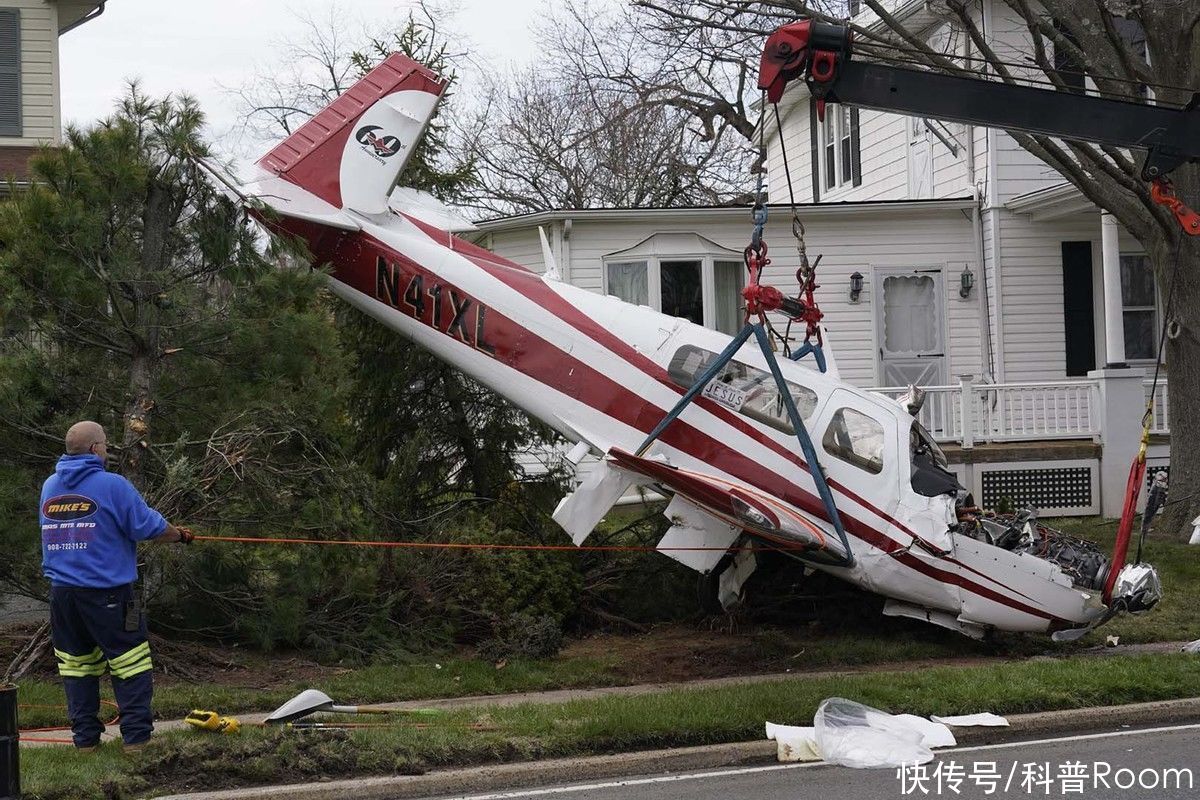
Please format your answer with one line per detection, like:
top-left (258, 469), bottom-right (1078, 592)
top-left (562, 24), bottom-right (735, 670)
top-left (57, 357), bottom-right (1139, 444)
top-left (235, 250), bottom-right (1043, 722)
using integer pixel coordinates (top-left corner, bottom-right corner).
top-left (422, 726), bottom-right (1200, 800)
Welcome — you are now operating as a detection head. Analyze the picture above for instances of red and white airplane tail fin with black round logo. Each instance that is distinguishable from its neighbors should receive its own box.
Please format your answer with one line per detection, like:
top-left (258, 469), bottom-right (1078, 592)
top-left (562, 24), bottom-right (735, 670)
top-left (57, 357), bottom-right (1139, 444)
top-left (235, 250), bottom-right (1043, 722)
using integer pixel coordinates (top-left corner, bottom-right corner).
top-left (258, 53), bottom-right (446, 213)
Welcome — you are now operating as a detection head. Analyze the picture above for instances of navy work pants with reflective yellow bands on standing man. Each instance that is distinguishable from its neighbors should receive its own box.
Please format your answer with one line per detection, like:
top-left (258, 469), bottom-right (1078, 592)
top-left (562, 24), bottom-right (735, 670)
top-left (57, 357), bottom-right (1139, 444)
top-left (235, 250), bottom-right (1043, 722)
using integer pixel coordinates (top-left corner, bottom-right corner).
top-left (50, 585), bottom-right (154, 747)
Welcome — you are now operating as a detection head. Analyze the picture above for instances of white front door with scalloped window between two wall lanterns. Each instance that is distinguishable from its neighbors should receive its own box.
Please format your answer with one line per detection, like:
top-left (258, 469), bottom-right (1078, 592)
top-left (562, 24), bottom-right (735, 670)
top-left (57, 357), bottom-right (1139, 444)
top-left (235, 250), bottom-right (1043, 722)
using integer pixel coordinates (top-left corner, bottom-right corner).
top-left (875, 269), bottom-right (946, 386)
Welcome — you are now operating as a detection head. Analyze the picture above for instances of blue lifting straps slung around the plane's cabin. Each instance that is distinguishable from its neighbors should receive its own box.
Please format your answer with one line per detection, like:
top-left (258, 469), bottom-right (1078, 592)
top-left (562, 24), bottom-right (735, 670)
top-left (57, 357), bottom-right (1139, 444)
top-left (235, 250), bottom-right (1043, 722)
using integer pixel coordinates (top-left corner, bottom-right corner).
top-left (636, 321), bottom-right (854, 567)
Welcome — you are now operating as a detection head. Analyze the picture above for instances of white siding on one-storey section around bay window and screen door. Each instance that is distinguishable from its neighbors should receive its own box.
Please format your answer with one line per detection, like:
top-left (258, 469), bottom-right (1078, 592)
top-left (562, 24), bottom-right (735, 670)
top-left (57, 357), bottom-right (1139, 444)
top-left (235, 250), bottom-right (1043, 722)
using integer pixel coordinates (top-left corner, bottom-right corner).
top-left (472, 205), bottom-right (983, 386)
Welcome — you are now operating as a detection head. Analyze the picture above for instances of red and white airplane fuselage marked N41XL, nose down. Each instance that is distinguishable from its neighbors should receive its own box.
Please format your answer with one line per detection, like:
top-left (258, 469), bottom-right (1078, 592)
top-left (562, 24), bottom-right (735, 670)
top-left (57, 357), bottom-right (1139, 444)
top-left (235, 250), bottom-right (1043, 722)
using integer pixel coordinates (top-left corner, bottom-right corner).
top-left (267, 213), bottom-right (1104, 632)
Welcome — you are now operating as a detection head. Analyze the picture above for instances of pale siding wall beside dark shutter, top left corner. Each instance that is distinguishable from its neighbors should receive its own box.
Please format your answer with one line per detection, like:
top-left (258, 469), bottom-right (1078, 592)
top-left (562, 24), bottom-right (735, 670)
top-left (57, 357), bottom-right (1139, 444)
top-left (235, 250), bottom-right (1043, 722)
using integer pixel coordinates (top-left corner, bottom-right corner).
top-left (0, 0), bottom-right (60, 146)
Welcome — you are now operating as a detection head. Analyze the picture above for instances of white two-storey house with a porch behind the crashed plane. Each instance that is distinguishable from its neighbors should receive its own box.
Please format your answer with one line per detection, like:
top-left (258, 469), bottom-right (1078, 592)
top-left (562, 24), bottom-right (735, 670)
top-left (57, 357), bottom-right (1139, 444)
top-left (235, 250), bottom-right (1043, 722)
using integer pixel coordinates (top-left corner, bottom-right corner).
top-left (476, 0), bottom-right (1168, 513)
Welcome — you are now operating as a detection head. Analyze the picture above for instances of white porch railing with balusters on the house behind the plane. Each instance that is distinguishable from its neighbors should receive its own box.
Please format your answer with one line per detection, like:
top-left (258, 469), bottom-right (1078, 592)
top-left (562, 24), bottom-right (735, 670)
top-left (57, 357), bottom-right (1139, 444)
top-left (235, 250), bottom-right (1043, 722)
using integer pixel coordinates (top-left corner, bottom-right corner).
top-left (871, 379), bottom-right (1100, 447)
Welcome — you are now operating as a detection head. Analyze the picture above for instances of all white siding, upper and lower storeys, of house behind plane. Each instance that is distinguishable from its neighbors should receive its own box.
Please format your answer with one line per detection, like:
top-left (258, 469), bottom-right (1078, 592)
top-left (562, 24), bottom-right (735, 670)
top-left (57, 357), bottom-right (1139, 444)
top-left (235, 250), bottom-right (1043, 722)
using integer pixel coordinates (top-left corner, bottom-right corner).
top-left (497, 0), bottom-right (1136, 385)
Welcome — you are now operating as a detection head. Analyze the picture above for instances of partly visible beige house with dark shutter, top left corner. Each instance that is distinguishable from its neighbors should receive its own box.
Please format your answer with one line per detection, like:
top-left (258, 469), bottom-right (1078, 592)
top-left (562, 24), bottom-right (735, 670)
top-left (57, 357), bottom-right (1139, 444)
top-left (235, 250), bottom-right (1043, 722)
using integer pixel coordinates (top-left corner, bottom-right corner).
top-left (0, 0), bottom-right (104, 182)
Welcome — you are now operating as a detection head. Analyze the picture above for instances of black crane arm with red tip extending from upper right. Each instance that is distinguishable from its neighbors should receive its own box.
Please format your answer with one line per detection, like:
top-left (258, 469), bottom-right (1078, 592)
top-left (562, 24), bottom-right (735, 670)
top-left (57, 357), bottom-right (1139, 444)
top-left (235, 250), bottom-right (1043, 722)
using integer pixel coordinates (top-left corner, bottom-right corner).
top-left (758, 19), bottom-right (1200, 235)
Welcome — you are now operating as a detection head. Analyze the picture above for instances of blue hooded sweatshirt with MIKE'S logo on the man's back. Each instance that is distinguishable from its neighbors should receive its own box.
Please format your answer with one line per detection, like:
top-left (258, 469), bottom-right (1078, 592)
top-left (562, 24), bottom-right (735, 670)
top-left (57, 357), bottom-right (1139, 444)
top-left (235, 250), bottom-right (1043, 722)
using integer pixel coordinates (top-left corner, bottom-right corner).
top-left (41, 453), bottom-right (167, 589)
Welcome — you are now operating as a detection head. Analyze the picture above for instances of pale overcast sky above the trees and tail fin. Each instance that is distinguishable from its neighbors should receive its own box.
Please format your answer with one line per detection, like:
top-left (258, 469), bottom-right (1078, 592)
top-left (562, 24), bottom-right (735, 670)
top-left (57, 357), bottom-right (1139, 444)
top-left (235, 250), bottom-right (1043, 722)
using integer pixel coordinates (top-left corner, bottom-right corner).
top-left (59, 0), bottom-right (561, 160)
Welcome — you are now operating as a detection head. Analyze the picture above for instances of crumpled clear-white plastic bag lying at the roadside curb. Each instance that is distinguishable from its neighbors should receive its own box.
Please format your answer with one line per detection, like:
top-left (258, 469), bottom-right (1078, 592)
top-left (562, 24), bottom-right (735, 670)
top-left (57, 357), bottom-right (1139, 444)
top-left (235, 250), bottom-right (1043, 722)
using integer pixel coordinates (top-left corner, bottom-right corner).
top-left (812, 697), bottom-right (934, 769)
